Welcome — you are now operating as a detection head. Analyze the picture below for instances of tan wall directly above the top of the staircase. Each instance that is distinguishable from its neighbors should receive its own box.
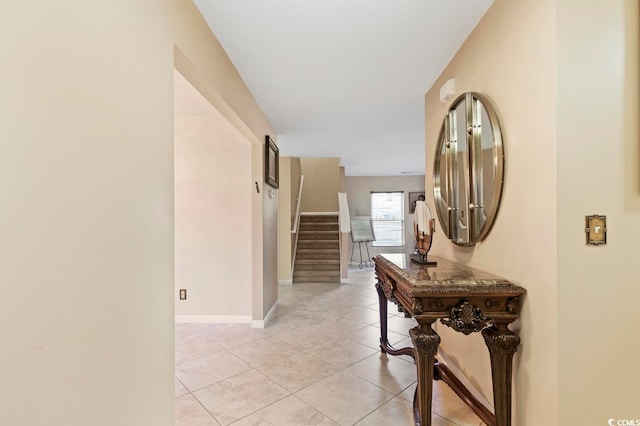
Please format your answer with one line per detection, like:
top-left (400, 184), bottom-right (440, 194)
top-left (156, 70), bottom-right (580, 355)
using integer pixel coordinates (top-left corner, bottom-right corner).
top-left (300, 158), bottom-right (340, 213)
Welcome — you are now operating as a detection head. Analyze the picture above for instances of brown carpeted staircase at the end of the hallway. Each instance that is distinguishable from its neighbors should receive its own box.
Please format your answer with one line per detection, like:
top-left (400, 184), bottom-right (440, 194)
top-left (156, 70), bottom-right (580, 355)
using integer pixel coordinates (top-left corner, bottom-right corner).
top-left (293, 215), bottom-right (340, 284)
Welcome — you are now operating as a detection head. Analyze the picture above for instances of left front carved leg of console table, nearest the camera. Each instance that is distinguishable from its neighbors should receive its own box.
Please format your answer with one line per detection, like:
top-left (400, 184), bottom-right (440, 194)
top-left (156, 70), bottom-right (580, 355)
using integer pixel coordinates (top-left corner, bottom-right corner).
top-left (409, 322), bottom-right (440, 426)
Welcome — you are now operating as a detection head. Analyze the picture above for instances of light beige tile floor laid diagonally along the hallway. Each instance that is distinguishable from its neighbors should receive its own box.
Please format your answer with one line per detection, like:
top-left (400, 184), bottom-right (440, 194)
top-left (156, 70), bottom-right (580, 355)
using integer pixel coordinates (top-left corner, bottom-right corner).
top-left (175, 268), bottom-right (484, 426)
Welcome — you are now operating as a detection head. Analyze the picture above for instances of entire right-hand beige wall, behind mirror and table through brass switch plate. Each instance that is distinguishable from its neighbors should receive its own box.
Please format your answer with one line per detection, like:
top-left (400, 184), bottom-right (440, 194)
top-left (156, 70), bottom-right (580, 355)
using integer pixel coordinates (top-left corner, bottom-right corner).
top-left (426, 0), bottom-right (640, 426)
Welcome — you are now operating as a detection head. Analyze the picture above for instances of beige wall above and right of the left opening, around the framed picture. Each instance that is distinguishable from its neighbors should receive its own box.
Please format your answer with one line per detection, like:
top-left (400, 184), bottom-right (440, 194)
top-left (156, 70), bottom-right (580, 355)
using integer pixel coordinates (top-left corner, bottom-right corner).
top-left (171, 4), bottom-right (278, 326)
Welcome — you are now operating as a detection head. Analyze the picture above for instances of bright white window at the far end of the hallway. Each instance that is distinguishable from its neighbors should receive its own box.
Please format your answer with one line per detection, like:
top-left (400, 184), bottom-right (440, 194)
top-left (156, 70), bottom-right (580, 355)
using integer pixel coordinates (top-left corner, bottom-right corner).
top-left (371, 191), bottom-right (404, 247)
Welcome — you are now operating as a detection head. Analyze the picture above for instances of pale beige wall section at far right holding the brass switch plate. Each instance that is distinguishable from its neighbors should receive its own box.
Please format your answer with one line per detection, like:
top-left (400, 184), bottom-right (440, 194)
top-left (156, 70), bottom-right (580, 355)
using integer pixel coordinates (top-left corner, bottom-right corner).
top-left (557, 0), bottom-right (640, 425)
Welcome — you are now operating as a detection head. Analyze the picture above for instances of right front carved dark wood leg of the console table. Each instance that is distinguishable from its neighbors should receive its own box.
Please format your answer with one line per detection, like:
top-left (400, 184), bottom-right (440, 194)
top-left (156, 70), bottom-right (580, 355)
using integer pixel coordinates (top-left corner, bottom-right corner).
top-left (482, 324), bottom-right (520, 426)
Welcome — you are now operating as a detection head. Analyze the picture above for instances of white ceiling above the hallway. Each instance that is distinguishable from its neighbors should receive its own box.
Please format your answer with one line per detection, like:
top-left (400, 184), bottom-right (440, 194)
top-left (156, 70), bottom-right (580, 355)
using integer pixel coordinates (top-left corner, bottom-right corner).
top-left (194, 0), bottom-right (493, 176)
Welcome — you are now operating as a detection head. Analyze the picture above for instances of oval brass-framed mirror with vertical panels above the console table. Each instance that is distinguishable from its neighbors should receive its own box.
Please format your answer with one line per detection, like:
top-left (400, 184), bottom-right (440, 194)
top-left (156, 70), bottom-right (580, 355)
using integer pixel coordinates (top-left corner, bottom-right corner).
top-left (433, 92), bottom-right (504, 246)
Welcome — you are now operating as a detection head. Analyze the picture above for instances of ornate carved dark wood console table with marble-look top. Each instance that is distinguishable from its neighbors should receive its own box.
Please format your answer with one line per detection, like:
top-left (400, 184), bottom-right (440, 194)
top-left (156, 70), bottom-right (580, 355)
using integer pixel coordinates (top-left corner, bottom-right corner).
top-left (373, 254), bottom-right (525, 426)
